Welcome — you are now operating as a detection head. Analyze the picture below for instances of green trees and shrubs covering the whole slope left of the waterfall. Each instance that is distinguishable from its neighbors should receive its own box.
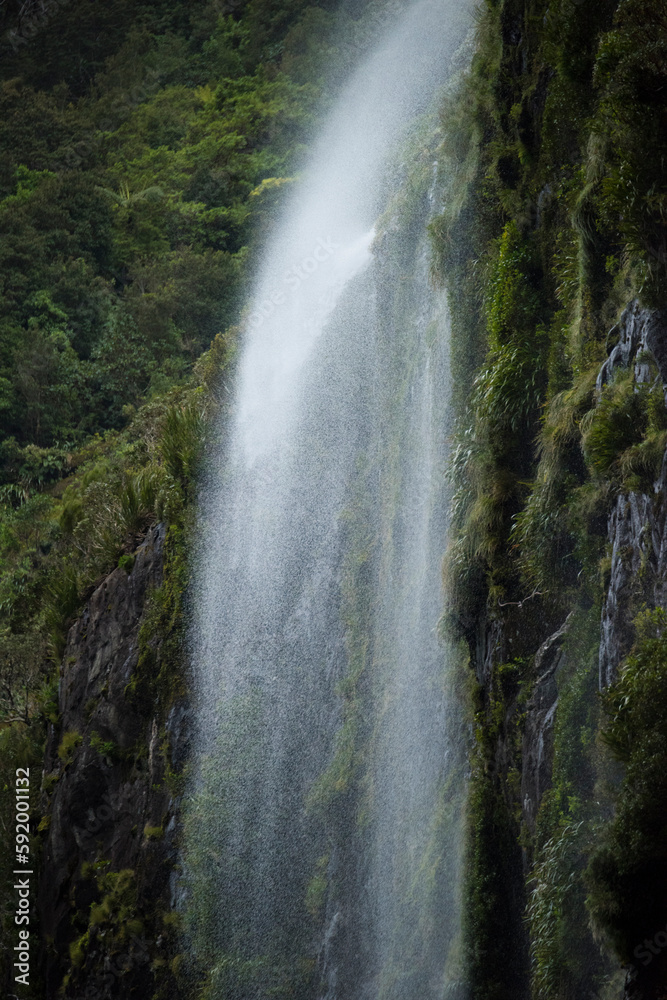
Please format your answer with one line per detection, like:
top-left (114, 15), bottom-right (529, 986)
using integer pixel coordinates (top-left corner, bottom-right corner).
top-left (0, 0), bottom-right (392, 995)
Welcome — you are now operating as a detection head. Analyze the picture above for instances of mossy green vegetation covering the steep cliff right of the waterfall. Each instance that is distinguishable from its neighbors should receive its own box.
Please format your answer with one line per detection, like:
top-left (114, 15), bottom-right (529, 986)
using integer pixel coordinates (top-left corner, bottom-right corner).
top-left (432, 0), bottom-right (667, 1000)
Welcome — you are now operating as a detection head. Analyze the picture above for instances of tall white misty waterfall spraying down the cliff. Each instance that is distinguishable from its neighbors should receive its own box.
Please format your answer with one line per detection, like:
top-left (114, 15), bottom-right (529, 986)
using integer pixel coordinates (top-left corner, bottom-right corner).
top-left (184, 0), bottom-right (464, 1000)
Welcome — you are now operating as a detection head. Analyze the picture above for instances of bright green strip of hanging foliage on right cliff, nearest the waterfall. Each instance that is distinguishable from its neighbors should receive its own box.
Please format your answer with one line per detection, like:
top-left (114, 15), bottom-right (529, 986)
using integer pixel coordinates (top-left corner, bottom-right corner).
top-left (447, 225), bottom-right (548, 620)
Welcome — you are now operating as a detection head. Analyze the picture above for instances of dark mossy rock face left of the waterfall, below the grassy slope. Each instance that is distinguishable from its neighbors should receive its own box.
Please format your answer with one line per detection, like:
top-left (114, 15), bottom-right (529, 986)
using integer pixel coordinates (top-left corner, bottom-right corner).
top-left (39, 525), bottom-right (187, 997)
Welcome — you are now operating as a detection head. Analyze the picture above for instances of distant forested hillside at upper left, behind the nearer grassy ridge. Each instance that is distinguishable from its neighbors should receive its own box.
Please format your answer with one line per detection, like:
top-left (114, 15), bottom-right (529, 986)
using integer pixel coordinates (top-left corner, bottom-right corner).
top-left (0, 0), bottom-right (376, 466)
